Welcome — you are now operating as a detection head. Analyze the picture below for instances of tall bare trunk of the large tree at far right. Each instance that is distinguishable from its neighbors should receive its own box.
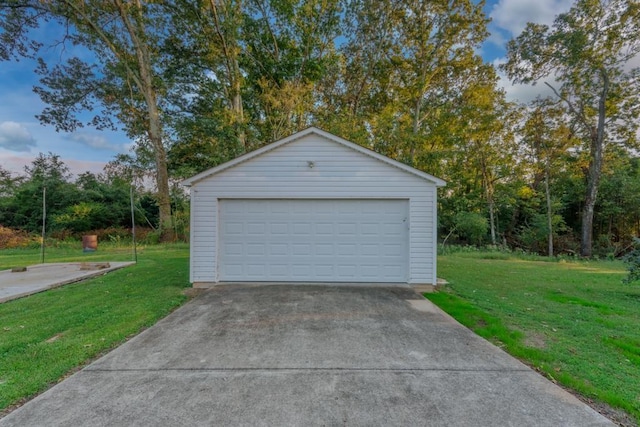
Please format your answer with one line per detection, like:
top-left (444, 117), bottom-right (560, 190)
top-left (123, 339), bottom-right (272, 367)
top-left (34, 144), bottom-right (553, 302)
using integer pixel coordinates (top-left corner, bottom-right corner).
top-left (580, 70), bottom-right (609, 257)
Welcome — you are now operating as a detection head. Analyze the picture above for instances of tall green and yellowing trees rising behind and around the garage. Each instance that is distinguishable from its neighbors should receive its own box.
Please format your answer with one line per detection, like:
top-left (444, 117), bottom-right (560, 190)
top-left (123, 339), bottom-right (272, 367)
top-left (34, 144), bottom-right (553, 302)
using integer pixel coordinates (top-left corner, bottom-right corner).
top-left (0, 0), bottom-right (640, 257)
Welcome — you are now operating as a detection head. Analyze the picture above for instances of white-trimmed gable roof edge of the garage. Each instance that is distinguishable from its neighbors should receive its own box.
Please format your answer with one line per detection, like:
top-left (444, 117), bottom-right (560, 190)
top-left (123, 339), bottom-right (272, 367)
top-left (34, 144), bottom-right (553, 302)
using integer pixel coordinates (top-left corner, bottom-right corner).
top-left (182, 126), bottom-right (446, 187)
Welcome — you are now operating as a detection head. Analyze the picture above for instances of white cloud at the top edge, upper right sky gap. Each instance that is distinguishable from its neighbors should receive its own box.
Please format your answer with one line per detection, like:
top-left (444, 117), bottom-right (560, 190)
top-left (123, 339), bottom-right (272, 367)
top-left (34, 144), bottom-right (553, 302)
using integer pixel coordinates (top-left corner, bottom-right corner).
top-left (489, 0), bottom-right (573, 36)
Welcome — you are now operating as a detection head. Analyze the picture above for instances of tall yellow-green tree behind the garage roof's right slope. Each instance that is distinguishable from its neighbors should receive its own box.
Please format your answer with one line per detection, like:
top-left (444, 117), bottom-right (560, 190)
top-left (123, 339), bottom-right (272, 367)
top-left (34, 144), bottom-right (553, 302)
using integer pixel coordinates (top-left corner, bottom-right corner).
top-left (336, 0), bottom-right (487, 167)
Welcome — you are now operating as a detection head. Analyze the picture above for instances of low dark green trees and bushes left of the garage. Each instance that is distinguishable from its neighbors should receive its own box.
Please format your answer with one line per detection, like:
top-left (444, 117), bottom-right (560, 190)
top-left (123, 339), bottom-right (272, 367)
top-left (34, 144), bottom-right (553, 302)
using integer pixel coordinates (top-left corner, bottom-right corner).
top-left (0, 153), bottom-right (188, 239)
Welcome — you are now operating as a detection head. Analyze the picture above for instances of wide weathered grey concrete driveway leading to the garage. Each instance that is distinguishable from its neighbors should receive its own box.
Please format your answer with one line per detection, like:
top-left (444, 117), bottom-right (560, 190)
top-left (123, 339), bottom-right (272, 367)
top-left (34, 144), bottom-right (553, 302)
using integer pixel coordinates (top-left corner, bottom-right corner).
top-left (0, 285), bottom-right (612, 427)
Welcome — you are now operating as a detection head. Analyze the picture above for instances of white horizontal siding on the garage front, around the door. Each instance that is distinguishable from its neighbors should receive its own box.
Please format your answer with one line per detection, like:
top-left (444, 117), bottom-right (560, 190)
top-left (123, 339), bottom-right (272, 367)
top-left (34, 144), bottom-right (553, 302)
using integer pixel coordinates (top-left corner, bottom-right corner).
top-left (191, 134), bottom-right (436, 284)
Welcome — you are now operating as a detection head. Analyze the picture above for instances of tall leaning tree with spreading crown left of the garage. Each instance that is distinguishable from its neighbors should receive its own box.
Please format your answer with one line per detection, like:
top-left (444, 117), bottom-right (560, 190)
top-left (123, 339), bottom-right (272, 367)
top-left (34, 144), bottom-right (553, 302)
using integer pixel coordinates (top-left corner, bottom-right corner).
top-left (0, 0), bottom-right (178, 240)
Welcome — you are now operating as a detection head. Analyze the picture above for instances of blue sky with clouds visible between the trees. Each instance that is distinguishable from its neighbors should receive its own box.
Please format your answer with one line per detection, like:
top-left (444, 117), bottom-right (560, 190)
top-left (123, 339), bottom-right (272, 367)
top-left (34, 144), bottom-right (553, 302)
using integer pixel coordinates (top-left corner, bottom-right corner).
top-left (0, 0), bottom-right (573, 175)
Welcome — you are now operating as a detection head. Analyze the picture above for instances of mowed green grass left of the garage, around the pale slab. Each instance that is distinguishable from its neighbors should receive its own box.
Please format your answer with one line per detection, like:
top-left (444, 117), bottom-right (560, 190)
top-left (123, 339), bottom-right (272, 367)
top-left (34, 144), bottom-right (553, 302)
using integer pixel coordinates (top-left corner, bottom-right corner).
top-left (0, 244), bottom-right (189, 414)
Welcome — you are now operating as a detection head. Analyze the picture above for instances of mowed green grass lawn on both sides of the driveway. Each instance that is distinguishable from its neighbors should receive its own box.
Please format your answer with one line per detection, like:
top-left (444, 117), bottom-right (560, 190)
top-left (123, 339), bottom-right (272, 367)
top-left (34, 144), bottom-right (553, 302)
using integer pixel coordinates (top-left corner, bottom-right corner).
top-left (6, 244), bottom-right (640, 420)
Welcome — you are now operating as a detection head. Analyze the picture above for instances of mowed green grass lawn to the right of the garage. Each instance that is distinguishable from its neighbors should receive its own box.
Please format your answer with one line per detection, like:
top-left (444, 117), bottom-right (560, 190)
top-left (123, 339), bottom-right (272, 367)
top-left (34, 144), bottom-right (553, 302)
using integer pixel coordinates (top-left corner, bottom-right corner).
top-left (425, 253), bottom-right (640, 422)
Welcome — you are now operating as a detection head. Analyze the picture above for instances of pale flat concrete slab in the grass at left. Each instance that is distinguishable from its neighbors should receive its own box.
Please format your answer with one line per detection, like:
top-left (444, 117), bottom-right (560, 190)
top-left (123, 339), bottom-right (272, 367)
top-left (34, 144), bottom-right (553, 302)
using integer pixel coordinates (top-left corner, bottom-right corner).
top-left (0, 262), bottom-right (134, 303)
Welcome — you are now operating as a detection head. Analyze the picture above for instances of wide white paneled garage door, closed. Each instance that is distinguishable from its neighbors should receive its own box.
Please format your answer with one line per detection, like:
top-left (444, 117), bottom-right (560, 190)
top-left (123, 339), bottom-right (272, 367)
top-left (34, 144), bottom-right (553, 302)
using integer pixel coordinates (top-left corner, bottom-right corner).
top-left (218, 199), bottom-right (409, 282)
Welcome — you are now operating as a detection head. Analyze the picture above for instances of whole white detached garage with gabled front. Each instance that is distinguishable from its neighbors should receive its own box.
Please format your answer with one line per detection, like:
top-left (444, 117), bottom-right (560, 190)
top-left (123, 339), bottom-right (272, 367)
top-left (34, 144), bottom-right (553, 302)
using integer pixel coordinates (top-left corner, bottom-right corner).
top-left (184, 128), bottom-right (444, 287)
